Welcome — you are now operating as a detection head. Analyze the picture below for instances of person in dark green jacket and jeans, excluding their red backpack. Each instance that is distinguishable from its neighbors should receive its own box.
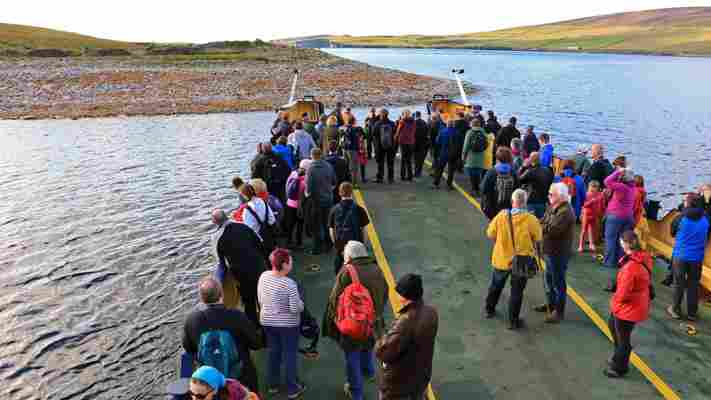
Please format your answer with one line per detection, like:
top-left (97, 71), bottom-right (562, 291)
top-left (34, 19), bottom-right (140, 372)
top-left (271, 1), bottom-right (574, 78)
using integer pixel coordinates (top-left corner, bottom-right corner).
top-left (322, 240), bottom-right (388, 400)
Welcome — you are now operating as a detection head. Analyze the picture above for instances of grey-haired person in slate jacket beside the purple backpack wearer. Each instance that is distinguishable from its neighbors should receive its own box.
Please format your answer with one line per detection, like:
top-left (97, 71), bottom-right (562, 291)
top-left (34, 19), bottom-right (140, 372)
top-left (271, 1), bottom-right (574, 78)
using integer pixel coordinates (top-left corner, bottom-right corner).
top-left (304, 149), bottom-right (336, 255)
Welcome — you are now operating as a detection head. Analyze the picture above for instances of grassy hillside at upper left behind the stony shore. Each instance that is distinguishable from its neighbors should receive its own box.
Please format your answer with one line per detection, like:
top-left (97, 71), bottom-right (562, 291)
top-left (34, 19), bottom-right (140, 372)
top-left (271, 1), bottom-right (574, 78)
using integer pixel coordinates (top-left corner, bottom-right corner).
top-left (0, 23), bottom-right (141, 51)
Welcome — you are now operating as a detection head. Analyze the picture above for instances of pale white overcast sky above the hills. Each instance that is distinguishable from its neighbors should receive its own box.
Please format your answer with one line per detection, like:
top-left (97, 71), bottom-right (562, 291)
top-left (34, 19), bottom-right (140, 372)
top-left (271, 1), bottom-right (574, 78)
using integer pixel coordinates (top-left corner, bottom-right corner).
top-left (5, 0), bottom-right (711, 43)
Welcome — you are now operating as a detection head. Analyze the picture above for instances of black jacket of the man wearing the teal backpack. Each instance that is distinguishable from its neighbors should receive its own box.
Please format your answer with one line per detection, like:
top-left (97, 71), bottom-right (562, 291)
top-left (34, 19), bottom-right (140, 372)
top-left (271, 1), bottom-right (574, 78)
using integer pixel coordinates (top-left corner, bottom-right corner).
top-left (183, 304), bottom-right (263, 391)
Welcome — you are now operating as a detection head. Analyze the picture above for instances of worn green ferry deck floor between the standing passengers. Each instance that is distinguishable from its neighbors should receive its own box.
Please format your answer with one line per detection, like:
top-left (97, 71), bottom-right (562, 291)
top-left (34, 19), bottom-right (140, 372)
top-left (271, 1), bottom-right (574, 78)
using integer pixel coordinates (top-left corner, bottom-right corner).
top-left (257, 163), bottom-right (711, 400)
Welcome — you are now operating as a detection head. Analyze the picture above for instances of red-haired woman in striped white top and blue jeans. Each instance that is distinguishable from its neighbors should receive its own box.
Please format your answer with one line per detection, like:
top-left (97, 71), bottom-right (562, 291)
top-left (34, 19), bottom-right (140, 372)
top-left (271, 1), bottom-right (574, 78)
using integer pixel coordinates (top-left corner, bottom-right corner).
top-left (257, 249), bottom-right (306, 399)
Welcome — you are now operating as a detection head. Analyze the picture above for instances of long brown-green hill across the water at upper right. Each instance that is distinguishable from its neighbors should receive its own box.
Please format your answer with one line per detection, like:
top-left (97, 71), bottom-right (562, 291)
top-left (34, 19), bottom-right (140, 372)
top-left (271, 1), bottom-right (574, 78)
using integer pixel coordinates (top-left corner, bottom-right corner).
top-left (278, 7), bottom-right (711, 55)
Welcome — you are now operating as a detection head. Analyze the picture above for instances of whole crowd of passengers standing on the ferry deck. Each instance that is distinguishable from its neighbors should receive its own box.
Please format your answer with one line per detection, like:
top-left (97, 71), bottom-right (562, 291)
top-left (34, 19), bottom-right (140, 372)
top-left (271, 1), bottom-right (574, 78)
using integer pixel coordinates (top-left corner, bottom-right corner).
top-left (174, 103), bottom-right (711, 400)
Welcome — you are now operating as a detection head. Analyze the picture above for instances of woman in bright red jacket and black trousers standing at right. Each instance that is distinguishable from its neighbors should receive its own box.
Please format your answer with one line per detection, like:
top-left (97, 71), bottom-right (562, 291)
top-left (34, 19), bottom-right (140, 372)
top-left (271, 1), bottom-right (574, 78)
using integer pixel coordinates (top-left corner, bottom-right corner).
top-left (604, 231), bottom-right (652, 378)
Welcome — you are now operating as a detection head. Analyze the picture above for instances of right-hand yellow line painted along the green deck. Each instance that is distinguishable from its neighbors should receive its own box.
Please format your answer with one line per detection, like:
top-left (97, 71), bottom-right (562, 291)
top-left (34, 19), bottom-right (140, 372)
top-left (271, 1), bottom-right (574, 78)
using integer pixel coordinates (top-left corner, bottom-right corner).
top-left (427, 161), bottom-right (680, 400)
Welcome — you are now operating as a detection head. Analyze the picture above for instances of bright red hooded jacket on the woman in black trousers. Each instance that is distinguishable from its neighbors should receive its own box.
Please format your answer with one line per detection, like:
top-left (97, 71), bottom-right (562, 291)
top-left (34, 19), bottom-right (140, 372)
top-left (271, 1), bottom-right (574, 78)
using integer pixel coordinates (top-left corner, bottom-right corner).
top-left (610, 251), bottom-right (652, 322)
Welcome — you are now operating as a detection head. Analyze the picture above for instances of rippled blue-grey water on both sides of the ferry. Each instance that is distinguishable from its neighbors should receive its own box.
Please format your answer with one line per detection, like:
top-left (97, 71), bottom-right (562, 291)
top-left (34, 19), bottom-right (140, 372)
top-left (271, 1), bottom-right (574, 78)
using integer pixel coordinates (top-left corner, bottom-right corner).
top-left (0, 49), bottom-right (711, 400)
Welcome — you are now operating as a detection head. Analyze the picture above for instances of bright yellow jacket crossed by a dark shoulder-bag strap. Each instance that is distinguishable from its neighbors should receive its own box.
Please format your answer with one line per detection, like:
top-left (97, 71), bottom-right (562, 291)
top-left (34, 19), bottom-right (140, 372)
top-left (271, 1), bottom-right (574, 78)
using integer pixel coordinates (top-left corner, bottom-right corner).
top-left (486, 210), bottom-right (543, 271)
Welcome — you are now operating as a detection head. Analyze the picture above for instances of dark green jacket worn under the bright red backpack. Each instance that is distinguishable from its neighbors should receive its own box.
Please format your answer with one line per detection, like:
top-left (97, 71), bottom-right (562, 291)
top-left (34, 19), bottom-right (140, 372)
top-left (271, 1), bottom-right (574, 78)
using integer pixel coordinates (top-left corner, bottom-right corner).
top-left (321, 257), bottom-right (388, 352)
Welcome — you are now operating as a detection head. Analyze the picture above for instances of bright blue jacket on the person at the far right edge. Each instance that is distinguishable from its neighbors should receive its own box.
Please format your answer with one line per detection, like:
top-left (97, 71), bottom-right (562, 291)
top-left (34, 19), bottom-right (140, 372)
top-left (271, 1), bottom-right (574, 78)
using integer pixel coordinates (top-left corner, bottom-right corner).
top-left (672, 208), bottom-right (709, 262)
